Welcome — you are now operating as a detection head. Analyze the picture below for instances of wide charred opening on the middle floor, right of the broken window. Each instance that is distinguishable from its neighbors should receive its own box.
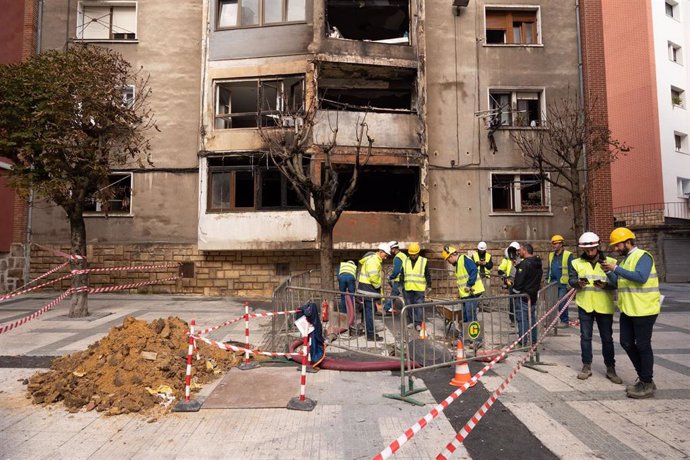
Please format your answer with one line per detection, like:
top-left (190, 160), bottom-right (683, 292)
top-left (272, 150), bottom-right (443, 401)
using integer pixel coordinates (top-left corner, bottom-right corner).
top-left (318, 63), bottom-right (417, 112)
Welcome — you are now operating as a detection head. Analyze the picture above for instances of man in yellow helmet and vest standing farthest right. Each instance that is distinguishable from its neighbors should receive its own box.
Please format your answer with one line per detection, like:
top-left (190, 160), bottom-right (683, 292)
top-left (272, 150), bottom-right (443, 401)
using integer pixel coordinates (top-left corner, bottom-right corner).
top-left (601, 227), bottom-right (661, 399)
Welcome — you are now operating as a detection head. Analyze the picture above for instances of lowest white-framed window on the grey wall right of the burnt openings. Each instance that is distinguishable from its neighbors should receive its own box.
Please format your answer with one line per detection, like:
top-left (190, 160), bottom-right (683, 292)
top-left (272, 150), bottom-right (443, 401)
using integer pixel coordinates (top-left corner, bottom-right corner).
top-left (491, 174), bottom-right (549, 212)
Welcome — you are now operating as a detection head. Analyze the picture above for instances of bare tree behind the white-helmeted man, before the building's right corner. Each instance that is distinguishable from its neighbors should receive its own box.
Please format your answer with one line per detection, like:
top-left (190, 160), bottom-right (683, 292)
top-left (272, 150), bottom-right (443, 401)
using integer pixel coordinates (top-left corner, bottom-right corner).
top-left (510, 96), bottom-right (630, 233)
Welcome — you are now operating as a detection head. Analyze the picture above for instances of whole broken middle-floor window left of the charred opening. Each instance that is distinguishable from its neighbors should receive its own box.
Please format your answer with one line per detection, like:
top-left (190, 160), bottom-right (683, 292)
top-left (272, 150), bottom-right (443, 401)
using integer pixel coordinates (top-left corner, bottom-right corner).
top-left (214, 76), bottom-right (304, 129)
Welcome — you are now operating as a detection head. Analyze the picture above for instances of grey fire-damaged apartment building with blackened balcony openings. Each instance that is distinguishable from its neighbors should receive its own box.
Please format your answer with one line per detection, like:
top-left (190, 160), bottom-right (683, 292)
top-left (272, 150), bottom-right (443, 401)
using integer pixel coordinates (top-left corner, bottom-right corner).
top-left (9, 0), bottom-right (592, 295)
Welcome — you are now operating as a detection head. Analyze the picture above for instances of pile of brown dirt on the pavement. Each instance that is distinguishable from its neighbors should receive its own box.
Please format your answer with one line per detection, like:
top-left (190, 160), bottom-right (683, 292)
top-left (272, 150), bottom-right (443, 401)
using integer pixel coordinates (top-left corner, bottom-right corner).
top-left (27, 316), bottom-right (253, 415)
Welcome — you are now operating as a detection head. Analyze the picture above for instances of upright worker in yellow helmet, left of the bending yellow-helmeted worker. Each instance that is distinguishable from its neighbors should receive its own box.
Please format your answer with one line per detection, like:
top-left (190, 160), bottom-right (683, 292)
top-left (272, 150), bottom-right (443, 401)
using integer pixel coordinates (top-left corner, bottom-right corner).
top-left (401, 243), bottom-right (431, 331)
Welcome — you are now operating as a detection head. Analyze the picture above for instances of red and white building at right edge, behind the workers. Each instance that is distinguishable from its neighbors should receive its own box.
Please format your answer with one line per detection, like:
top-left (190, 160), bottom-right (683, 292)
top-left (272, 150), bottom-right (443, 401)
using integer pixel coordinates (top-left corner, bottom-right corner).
top-left (602, 0), bottom-right (690, 281)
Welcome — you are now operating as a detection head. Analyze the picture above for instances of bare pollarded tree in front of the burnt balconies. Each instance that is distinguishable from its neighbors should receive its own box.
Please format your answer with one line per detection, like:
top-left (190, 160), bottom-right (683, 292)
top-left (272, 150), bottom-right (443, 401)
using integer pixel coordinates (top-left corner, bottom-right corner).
top-left (259, 97), bottom-right (374, 289)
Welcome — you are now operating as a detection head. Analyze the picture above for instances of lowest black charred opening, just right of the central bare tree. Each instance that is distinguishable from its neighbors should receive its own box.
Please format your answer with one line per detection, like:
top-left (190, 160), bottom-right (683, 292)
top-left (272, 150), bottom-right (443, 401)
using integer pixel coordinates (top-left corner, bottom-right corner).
top-left (336, 165), bottom-right (420, 213)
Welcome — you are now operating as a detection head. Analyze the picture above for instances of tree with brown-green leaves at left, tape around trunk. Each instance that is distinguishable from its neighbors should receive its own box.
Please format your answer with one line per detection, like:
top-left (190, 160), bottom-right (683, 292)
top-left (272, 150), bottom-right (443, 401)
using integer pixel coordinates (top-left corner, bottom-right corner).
top-left (0, 45), bottom-right (156, 317)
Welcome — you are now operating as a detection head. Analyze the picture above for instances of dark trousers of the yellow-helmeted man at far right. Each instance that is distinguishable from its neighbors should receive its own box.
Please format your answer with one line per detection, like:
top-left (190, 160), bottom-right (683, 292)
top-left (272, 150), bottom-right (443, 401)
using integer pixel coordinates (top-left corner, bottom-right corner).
top-left (620, 312), bottom-right (659, 383)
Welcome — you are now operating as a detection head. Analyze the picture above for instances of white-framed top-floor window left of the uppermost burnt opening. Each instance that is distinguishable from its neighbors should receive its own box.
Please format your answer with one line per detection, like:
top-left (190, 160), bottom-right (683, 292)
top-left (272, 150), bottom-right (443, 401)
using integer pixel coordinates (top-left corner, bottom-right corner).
top-left (217, 0), bottom-right (306, 29)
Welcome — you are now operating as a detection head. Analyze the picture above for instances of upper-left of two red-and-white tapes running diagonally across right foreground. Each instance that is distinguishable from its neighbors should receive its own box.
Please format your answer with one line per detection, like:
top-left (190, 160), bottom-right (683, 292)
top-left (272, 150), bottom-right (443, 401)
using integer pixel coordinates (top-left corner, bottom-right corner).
top-left (374, 293), bottom-right (574, 460)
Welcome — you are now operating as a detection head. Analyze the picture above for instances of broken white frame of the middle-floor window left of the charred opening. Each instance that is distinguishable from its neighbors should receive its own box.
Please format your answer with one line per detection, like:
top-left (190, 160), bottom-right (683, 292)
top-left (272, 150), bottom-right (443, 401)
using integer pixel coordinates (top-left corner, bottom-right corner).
top-left (212, 74), bottom-right (306, 131)
